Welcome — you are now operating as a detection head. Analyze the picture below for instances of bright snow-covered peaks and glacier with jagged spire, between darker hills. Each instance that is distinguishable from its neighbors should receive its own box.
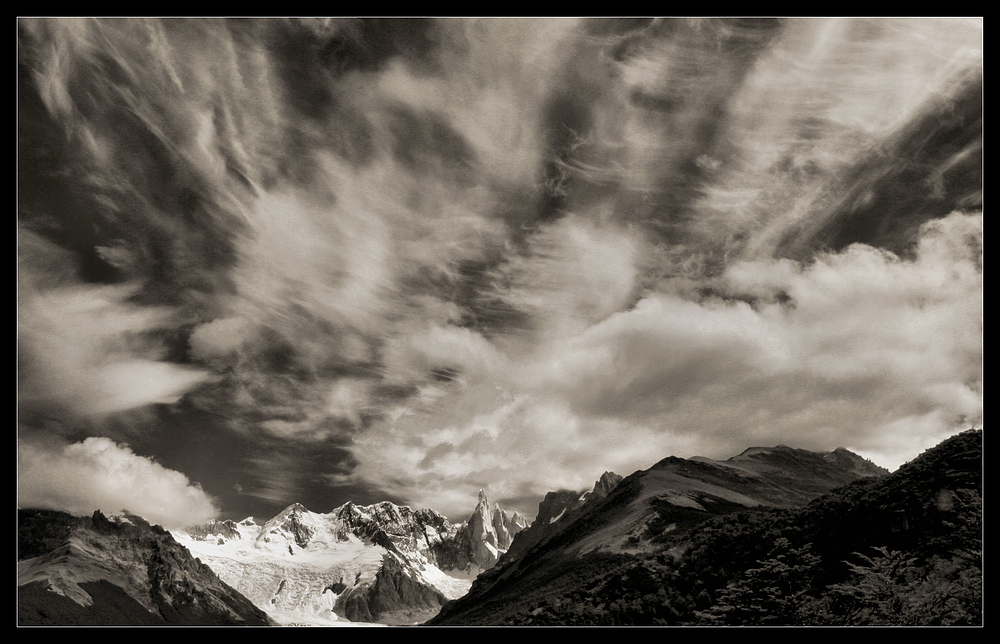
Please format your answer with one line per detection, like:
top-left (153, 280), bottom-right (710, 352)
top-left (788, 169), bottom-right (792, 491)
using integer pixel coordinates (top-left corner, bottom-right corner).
top-left (177, 493), bottom-right (526, 624)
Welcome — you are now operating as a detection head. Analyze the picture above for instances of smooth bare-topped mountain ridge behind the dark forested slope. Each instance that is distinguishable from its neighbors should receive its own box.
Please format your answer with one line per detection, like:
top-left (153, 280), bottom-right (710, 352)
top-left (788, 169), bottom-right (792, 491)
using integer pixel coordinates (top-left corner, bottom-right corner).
top-left (430, 446), bottom-right (887, 624)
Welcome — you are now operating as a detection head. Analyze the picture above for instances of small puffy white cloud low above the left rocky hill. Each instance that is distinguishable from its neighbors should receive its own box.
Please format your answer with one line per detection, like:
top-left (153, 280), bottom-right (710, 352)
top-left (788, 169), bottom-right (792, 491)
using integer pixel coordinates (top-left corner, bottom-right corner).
top-left (17, 437), bottom-right (218, 529)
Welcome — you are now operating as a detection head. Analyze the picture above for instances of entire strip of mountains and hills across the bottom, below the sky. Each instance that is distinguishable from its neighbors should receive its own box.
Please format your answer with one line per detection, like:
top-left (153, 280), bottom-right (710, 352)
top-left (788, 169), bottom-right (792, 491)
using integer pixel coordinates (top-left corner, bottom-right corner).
top-left (18, 430), bottom-right (982, 625)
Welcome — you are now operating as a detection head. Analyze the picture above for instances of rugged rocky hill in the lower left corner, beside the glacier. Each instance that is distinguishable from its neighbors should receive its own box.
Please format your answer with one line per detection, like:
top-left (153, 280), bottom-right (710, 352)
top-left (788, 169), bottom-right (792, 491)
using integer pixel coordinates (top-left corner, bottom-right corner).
top-left (17, 510), bottom-right (269, 626)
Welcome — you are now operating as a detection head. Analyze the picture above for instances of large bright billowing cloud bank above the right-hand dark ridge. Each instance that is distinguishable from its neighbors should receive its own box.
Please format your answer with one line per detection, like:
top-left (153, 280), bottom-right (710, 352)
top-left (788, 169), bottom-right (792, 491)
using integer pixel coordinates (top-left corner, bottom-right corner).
top-left (353, 214), bottom-right (982, 511)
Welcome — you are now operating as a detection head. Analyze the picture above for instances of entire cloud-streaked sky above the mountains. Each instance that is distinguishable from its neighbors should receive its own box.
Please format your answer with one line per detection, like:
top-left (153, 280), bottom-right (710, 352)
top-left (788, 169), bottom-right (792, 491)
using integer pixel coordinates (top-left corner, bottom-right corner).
top-left (17, 18), bottom-right (983, 527)
